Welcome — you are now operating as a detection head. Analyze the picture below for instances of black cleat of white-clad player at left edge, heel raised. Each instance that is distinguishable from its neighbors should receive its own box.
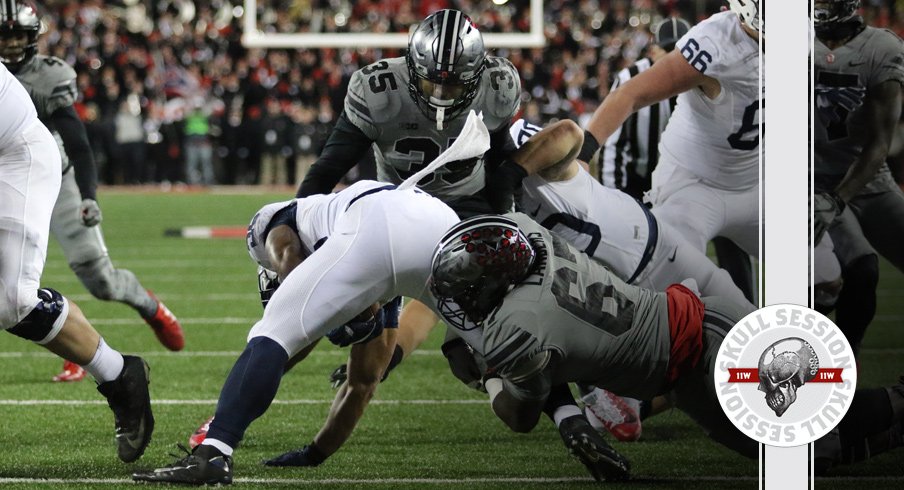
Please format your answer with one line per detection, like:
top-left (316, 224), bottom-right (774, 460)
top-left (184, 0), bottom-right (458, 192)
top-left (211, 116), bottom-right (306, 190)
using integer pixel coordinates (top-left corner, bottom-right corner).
top-left (97, 356), bottom-right (154, 463)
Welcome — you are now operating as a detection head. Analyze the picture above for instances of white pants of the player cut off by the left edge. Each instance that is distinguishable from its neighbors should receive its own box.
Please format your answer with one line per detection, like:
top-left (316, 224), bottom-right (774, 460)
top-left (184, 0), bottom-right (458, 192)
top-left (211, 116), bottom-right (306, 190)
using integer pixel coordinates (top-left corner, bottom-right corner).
top-left (0, 121), bottom-right (62, 330)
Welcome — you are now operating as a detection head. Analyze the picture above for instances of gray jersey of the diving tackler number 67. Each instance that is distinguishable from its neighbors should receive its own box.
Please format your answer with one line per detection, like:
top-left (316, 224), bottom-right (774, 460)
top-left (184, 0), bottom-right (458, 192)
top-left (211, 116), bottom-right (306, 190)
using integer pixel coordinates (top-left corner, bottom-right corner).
top-left (483, 213), bottom-right (671, 399)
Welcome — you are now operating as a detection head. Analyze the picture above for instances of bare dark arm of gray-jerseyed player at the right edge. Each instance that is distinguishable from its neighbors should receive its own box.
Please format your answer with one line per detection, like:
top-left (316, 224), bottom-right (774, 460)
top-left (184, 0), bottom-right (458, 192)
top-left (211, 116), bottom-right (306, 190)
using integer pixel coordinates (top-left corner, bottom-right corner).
top-left (835, 80), bottom-right (902, 202)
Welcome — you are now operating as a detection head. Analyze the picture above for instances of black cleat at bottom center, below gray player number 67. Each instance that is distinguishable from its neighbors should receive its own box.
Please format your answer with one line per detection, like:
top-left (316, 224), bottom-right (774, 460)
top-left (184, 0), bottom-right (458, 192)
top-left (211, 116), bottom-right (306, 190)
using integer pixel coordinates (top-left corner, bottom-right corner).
top-left (559, 415), bottom-right (631, 481)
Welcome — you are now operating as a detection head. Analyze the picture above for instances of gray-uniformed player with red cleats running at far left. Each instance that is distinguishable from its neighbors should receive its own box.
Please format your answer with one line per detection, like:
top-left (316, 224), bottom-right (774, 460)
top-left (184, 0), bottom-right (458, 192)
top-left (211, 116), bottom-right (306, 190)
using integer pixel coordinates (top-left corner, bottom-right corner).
top-left (0, 0), bottom-right (185, 381)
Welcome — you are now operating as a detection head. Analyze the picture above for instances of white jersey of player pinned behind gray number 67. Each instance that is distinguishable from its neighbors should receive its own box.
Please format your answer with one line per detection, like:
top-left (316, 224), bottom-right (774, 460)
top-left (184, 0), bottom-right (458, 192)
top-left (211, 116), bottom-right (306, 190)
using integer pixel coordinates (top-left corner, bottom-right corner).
top-left (510, 120), bottom-right (650, 280)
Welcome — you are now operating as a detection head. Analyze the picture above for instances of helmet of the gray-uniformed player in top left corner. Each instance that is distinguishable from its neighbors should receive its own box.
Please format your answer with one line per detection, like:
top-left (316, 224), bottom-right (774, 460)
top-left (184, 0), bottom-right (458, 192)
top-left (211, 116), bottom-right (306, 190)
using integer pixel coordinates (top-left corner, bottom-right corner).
top-left (0, 0), bottom-right (42, 73)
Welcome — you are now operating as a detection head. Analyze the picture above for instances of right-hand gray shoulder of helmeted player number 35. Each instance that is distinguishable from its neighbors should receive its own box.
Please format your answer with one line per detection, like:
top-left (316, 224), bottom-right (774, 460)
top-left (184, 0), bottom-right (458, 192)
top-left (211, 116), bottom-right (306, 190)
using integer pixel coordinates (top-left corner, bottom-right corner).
top-left (479, 56), bottom-right (521, 131)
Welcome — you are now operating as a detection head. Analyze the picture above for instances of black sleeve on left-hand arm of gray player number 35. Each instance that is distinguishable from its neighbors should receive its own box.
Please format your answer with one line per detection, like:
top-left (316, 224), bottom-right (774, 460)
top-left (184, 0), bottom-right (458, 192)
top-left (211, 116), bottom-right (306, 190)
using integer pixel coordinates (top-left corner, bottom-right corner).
top-left (295, 111), bottom-right (373, 198)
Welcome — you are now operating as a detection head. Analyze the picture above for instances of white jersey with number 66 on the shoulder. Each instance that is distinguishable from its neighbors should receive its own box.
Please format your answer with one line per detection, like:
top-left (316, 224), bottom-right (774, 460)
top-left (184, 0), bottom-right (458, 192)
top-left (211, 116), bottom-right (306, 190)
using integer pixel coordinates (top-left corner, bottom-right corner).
top-left (659, 11), bottom-right (765, 190)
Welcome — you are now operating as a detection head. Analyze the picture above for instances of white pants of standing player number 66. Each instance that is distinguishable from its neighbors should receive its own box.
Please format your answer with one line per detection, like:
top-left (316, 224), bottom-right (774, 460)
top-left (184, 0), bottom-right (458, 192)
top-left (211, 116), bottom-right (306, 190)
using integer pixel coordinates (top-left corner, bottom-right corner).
top-left (647, 161), bottom-right (760, 258)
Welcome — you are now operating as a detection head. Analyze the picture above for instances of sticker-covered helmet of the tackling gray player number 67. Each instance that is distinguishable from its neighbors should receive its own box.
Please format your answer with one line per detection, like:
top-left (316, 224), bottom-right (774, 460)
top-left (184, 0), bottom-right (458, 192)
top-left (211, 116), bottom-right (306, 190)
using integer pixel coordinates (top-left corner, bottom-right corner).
top-left (430, 215), bottom-right (536, 328)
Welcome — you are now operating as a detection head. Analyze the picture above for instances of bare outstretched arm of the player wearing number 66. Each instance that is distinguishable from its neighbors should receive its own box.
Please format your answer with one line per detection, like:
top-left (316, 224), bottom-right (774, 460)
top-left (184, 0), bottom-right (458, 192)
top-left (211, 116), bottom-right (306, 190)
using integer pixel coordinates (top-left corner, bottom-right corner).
top-left (579, 49), bottom-right (719, 161)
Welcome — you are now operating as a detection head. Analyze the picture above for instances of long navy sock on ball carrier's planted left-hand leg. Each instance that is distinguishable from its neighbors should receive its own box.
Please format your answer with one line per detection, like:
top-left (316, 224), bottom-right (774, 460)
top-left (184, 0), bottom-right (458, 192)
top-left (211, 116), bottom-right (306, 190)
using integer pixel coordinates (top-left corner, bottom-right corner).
top-left (207, 337), bottom-right (289, 448)
